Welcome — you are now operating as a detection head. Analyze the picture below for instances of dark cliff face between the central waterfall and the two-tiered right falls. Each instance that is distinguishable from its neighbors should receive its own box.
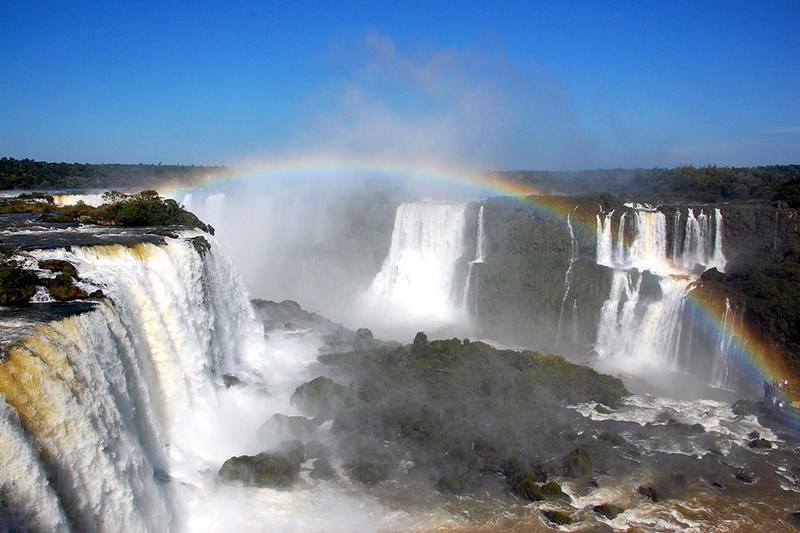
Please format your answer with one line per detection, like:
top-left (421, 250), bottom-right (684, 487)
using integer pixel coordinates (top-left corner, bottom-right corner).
top-left (470, 197), bottom-right (611, 355)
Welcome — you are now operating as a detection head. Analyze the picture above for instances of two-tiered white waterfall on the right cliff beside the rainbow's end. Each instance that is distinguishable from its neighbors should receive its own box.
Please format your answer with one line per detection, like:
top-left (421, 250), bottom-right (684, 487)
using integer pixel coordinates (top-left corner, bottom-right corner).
top-left (595, 205), bottom-right (729, 386)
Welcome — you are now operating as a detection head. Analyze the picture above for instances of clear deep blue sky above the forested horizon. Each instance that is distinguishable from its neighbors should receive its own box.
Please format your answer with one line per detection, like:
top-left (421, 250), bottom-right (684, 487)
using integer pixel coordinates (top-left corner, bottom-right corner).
top-left (0, 0), bottom-right (800, 170)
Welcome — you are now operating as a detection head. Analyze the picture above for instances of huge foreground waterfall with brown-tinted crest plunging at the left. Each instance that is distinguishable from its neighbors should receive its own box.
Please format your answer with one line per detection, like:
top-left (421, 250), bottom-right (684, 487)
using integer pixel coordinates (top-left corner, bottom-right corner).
top-left (0, 234), bottom-right (265, 531)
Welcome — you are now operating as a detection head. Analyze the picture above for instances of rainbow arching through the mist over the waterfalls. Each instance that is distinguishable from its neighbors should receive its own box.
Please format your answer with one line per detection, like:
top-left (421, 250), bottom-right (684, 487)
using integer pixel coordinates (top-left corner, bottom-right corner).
top-left (161, 155), bottom-right (790, 404)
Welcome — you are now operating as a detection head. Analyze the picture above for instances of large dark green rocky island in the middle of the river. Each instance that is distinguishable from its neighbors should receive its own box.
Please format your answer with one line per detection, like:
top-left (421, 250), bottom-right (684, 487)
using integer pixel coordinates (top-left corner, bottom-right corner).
top-left (292, 332), bottom-right (627, 490)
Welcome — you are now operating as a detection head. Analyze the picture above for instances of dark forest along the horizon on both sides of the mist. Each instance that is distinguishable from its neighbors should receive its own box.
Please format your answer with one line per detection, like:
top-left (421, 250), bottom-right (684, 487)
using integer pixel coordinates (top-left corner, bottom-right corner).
top-left (0, 157), bottom-right (800, 208)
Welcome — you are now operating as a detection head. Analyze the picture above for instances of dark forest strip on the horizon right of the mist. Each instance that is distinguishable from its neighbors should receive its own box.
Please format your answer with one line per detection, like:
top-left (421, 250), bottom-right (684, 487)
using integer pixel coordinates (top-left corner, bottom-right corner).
top-left (496, 165), bottom-right (800, 208)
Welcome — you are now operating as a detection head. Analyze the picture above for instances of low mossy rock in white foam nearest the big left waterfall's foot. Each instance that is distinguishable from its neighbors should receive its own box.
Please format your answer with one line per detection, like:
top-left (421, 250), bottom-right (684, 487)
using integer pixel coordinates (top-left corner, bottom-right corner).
top-left (219, 453), bottom-right (302, 487)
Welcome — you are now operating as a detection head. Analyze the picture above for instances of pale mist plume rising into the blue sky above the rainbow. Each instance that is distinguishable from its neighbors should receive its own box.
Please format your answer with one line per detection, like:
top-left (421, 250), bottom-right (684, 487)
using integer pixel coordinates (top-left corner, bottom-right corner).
top-left (290, 32), bottom-right (597, 169)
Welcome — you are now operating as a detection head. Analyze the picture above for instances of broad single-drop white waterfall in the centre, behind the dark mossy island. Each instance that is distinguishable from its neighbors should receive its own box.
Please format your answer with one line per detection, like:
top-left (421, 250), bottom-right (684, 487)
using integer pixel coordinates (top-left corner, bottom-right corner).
top-left (366, 202), bottom-right (466, 334)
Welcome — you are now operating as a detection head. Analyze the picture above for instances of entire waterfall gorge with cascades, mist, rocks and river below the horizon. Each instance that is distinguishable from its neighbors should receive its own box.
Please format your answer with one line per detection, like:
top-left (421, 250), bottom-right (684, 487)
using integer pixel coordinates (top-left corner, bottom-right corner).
top-left (0, 164), bottom-right (800, 531)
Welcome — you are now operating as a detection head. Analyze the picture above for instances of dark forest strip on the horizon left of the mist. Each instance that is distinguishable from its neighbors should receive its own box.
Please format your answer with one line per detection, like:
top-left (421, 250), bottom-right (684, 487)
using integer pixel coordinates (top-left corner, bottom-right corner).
top-left (0, 157), bottom-right (225, 190)
